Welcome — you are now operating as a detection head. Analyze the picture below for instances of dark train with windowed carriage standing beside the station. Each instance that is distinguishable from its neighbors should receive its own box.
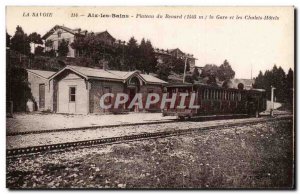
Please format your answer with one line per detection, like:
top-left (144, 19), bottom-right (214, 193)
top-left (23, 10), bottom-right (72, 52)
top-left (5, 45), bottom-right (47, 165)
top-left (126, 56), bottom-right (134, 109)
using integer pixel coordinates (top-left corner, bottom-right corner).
top-left (162, 83), bottom-right (267, 119)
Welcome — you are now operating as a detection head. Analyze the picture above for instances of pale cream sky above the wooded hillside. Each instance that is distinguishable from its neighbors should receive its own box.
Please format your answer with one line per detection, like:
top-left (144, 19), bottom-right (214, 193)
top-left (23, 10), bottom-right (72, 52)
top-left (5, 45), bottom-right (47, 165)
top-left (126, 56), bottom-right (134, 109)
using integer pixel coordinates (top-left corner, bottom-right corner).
top-left (6, 6), bottom-right (294, 79)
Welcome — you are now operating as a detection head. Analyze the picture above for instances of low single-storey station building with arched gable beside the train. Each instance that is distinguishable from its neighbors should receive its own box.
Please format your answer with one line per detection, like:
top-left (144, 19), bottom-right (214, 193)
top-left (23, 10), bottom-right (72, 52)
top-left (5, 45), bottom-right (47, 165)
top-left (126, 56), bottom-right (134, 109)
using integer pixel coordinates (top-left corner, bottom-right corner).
top-left (27, 65), bottom-right (167, 114)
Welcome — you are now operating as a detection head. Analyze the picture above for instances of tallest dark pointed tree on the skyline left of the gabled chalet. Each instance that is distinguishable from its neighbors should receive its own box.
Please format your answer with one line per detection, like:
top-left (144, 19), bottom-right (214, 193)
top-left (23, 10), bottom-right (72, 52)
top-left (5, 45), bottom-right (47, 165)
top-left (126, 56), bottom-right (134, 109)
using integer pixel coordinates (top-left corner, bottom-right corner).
top-left (11, 26), bottom-right (30, 55)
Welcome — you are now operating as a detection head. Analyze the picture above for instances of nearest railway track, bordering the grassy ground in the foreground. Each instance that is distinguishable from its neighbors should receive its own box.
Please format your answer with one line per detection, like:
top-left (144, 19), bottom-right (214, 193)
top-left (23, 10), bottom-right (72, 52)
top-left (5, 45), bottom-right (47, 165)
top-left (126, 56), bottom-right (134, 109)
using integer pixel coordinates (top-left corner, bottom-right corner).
top-left (6, 116), bottom-right (292, 157)
